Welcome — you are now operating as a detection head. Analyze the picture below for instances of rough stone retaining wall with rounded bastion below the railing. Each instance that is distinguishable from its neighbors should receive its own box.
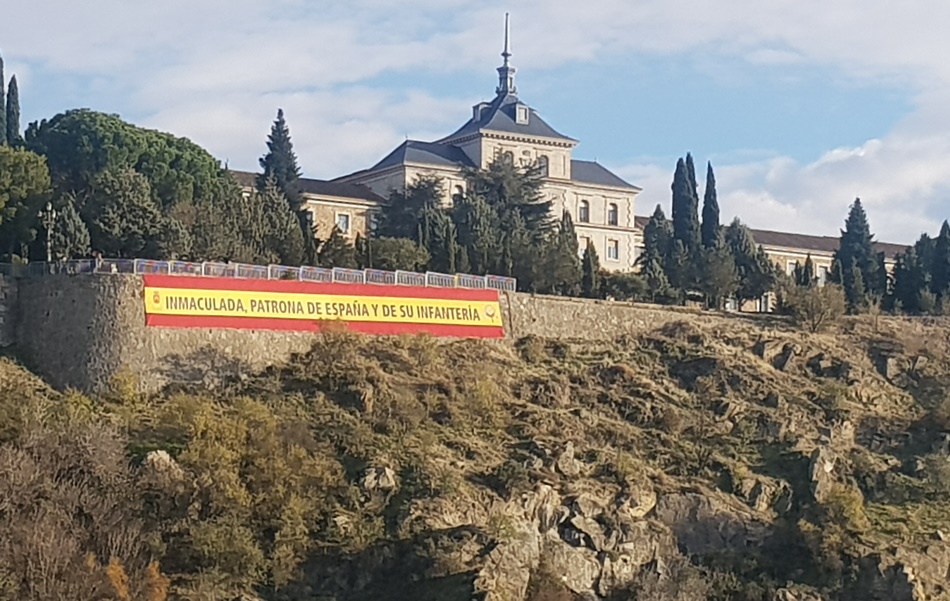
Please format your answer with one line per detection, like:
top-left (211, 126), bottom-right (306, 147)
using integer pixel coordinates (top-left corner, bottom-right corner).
top-left (0, 274), bottom-right (768, 390)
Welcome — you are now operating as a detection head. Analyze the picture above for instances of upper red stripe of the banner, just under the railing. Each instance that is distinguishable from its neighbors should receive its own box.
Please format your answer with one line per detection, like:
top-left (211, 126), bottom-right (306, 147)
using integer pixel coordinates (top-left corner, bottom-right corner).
top-left (142, 274), bottom-right (498, 301)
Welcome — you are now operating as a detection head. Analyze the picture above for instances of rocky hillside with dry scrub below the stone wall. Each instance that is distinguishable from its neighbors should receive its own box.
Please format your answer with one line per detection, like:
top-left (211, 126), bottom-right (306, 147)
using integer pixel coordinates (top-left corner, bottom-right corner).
top-left (0, 317), bottom-right (950, 601)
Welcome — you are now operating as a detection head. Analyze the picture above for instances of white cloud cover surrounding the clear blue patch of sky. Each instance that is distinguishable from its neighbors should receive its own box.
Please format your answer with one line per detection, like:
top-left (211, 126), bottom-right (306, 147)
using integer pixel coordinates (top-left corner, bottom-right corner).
top-left (0, 0), bottom-right (950, 241)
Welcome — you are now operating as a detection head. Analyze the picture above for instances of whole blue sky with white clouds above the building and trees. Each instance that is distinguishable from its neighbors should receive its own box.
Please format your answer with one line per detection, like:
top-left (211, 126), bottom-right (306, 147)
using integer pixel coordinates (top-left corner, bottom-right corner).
top-left (0, 0), bottom-right (950, 242)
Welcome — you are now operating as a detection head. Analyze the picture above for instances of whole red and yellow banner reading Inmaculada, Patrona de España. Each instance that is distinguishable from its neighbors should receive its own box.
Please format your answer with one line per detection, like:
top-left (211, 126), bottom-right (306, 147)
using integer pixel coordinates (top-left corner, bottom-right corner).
top-left (143, 275), bottom-right (504, 338)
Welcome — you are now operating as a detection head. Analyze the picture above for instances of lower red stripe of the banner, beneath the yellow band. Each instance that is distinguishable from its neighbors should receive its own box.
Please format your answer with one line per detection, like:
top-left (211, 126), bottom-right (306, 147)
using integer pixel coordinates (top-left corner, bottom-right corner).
top-left (145, 314), bottom-right (505, 338)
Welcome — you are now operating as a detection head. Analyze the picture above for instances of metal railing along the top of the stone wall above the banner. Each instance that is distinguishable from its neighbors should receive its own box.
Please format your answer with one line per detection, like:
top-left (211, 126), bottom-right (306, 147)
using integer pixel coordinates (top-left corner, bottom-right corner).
top-left (0, 259), bottom-right (517, 292)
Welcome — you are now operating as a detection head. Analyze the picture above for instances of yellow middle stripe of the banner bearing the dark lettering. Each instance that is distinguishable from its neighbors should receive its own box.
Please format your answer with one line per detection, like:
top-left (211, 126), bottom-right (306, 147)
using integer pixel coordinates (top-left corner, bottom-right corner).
top-left (145, 287), bottom-right (502, 327)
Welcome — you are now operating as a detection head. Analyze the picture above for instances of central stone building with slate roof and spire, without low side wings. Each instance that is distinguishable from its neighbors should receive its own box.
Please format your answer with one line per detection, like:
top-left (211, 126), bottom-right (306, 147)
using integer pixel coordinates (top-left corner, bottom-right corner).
top-left (333, 17), bottom-right (640, 271)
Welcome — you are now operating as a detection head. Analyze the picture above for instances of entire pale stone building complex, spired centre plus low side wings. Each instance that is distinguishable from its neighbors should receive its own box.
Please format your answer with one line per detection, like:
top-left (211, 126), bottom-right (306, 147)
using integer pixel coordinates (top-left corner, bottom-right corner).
top-left (235, 22), bottom-right (905, 288)
